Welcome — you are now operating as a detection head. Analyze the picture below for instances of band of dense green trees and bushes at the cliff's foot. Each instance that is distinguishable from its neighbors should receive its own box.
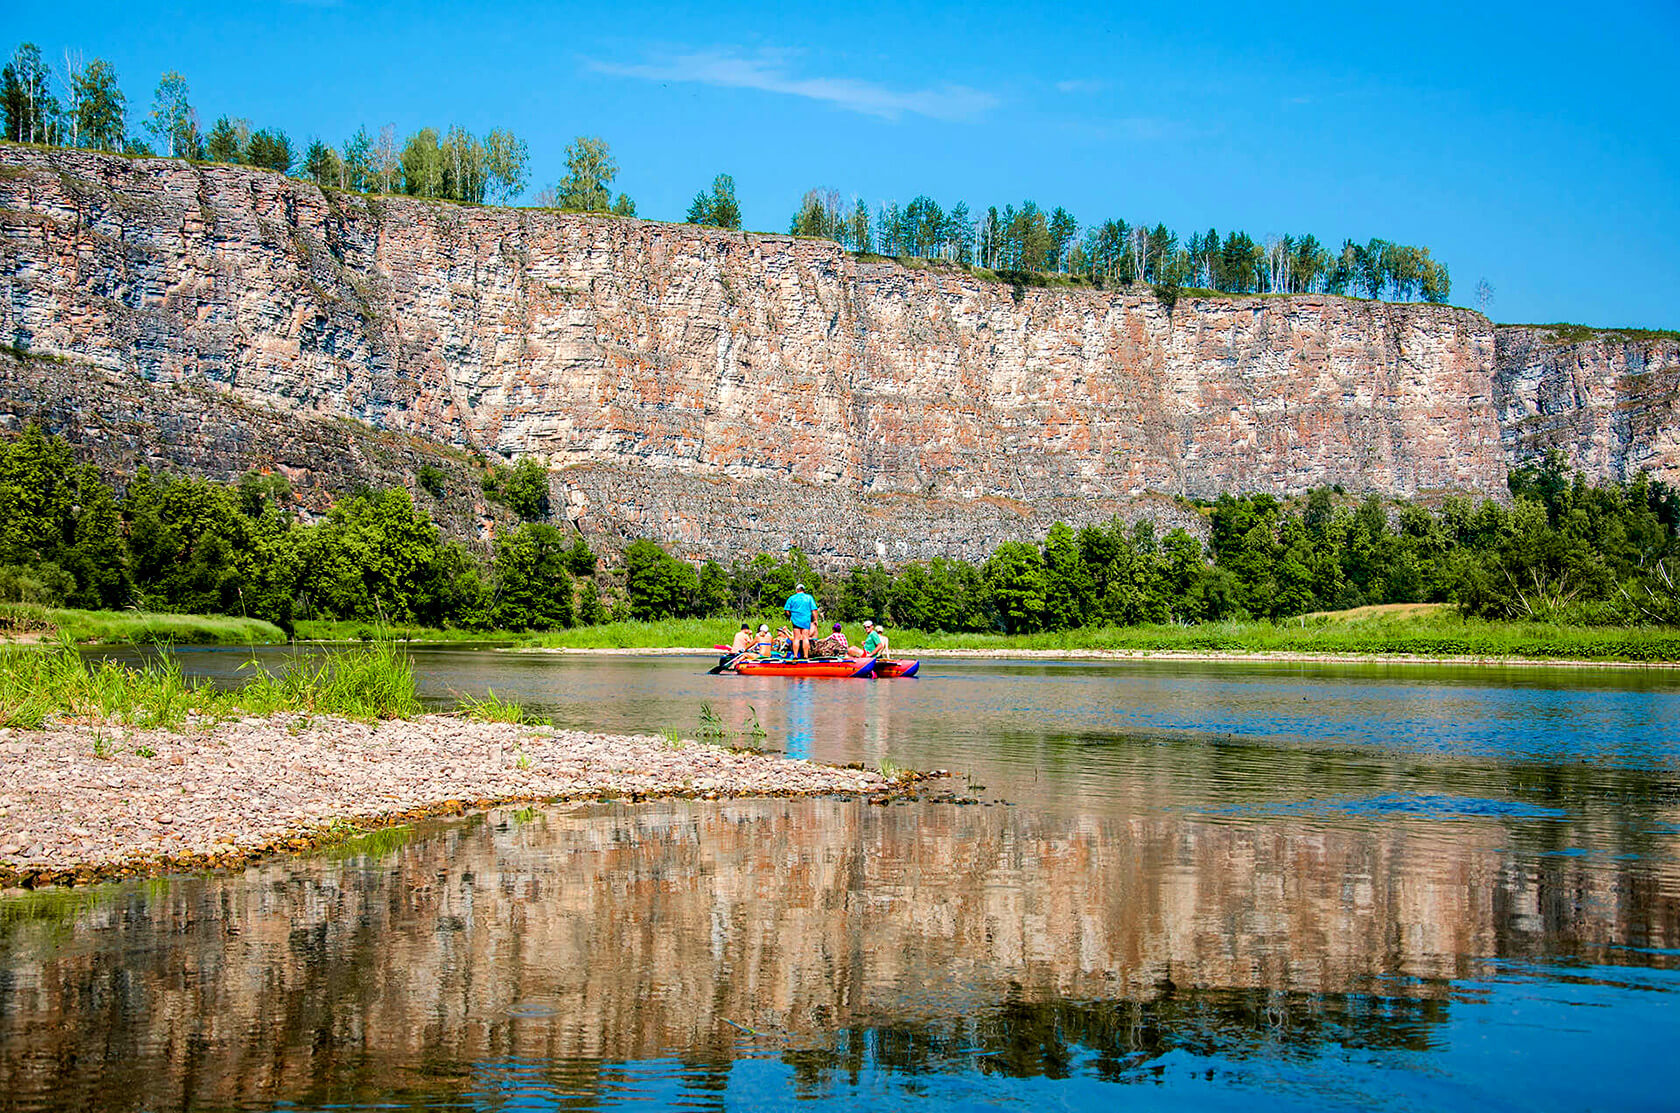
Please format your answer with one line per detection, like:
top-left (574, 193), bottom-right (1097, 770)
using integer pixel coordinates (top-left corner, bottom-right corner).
top-left (0, 427), bottom-right (1680, 634)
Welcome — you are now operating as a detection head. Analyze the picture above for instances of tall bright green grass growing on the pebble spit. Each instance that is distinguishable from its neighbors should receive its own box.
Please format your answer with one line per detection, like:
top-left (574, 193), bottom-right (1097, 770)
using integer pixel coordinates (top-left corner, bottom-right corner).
top-left (0, 642), bottom-right (420, 730)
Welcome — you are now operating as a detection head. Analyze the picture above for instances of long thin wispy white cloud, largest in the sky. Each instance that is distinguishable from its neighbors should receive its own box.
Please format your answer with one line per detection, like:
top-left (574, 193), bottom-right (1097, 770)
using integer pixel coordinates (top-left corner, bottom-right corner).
top-left (586, 50), bottom-right (998, 119)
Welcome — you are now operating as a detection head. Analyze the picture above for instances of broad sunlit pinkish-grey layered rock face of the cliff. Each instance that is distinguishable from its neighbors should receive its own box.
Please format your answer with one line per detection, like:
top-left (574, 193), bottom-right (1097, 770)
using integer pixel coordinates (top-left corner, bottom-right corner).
top-left (0, 146), bottom-right (1675, 558)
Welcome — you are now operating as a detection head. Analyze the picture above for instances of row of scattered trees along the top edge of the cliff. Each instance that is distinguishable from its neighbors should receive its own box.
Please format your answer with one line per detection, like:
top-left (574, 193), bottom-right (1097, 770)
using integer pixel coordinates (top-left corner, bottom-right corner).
top-left (0, 44), bottom-right (1452, 304)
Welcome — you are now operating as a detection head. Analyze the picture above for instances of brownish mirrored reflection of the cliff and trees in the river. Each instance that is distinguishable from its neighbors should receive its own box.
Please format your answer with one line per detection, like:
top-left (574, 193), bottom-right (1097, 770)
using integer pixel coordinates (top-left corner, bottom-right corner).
top-left (0, 802), bottom-right (1680, 1108)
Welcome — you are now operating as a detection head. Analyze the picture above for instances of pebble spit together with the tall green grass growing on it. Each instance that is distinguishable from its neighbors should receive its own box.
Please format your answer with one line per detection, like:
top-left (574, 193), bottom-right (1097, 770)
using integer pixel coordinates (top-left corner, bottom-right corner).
top-left (0, 644), bottom-right (912, 888)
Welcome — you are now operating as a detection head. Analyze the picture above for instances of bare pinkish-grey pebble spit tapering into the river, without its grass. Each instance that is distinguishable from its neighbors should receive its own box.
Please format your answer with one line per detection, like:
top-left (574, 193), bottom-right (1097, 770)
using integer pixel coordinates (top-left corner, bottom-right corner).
top-left (0, 715), bottom-right (902, 888)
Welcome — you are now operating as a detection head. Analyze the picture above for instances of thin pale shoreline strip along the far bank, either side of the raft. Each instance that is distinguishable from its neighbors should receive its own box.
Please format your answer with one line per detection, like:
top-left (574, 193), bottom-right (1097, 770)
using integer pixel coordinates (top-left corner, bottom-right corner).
top-left (517, 646), bottom-right (1680, 669)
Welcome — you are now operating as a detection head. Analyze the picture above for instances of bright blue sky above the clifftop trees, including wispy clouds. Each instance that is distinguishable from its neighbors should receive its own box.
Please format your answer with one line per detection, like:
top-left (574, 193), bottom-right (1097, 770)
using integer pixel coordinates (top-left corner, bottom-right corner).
top-left (3, 0), bottom-right (1680, 328)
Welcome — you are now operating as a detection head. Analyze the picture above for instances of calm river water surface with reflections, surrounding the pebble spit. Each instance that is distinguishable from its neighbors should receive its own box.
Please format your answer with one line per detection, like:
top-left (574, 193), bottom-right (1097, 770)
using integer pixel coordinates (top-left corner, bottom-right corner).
top-left (0, 651), bottom-right (1680, 1113)
